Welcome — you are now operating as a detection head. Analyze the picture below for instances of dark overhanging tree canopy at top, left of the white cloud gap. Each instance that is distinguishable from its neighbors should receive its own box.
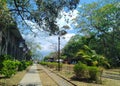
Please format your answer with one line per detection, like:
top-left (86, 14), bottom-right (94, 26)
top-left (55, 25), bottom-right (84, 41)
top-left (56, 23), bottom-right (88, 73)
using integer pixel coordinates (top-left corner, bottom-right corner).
top-left (7, 0), bottom-right (79, 34)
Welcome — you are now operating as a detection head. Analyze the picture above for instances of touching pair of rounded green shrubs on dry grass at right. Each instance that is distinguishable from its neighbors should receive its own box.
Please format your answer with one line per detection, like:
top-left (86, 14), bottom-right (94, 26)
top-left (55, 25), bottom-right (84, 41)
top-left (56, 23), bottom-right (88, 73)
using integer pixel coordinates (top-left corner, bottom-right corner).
top-left (74, 62), bottom-right (102, 83)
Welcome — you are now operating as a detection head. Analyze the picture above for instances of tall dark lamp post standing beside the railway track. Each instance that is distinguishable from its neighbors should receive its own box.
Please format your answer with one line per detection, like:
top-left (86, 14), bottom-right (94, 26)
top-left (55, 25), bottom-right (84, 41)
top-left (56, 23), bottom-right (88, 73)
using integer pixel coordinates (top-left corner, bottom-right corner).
top-left (58, 30), bottom-right (67, 71)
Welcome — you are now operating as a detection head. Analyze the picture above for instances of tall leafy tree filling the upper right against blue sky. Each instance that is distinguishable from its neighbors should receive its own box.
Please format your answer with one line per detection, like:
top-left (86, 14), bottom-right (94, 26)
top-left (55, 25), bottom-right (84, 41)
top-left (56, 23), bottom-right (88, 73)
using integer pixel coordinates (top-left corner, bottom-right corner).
top-left (75, 0), bottom-right (120, 64)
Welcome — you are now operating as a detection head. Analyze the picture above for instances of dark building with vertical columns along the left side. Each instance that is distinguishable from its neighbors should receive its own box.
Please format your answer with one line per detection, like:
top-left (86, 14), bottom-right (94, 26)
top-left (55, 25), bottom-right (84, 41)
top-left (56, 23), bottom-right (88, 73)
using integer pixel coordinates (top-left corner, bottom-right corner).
top-left (0, 26), bottom-right (30, 60)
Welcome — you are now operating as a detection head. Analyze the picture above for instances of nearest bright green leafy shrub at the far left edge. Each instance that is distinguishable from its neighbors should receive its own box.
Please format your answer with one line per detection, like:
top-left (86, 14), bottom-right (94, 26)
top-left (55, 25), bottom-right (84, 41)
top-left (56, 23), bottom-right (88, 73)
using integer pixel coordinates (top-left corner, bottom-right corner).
top-left (1, 60), bottom-right (17, 77)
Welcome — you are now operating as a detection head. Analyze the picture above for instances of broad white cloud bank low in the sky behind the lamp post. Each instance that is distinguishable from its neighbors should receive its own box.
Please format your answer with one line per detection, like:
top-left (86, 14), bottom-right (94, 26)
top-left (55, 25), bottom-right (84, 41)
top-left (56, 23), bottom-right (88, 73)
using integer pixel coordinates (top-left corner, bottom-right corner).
top-left (24, 33), bottom-right (75, 56)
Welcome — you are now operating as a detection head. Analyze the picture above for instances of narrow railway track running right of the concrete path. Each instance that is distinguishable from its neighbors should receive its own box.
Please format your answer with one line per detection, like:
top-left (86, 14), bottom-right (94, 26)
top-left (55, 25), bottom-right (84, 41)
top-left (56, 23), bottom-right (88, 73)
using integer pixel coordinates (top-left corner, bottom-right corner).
top-left (39, 65), bottom-right (77, 86)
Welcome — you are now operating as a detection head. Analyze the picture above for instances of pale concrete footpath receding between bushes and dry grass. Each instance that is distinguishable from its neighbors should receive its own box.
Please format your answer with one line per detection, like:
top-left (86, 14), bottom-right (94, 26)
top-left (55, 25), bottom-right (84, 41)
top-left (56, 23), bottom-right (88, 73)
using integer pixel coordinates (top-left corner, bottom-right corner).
top-left (18, 64), bottom-right (42, 86)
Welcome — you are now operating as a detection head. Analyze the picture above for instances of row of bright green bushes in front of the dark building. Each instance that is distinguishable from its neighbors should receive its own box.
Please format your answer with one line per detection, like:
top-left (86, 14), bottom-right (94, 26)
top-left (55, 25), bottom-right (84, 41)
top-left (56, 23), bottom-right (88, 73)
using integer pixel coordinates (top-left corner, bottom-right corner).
top-left (0, 55), bottom-right (32, 78)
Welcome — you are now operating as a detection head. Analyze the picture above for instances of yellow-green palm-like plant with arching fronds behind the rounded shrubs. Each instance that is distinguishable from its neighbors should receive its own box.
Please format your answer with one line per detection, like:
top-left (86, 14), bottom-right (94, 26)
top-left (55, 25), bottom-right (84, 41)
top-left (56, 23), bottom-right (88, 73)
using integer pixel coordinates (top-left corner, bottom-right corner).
top-left (76, 45), bottom-right (110, 68)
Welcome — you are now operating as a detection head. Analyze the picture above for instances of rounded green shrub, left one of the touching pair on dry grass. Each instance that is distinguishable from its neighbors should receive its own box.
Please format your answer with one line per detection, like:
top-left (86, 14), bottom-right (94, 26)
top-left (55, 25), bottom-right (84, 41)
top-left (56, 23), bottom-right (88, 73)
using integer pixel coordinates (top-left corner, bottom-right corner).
top-left (74, 62), bottom-right (89, 79)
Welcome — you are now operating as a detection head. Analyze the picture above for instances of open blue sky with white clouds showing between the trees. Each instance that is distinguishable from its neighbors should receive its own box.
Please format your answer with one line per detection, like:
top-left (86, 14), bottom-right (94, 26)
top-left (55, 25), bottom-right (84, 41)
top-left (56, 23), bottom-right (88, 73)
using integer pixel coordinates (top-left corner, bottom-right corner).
top-left (22, 0), bottom-right (96, 59)
